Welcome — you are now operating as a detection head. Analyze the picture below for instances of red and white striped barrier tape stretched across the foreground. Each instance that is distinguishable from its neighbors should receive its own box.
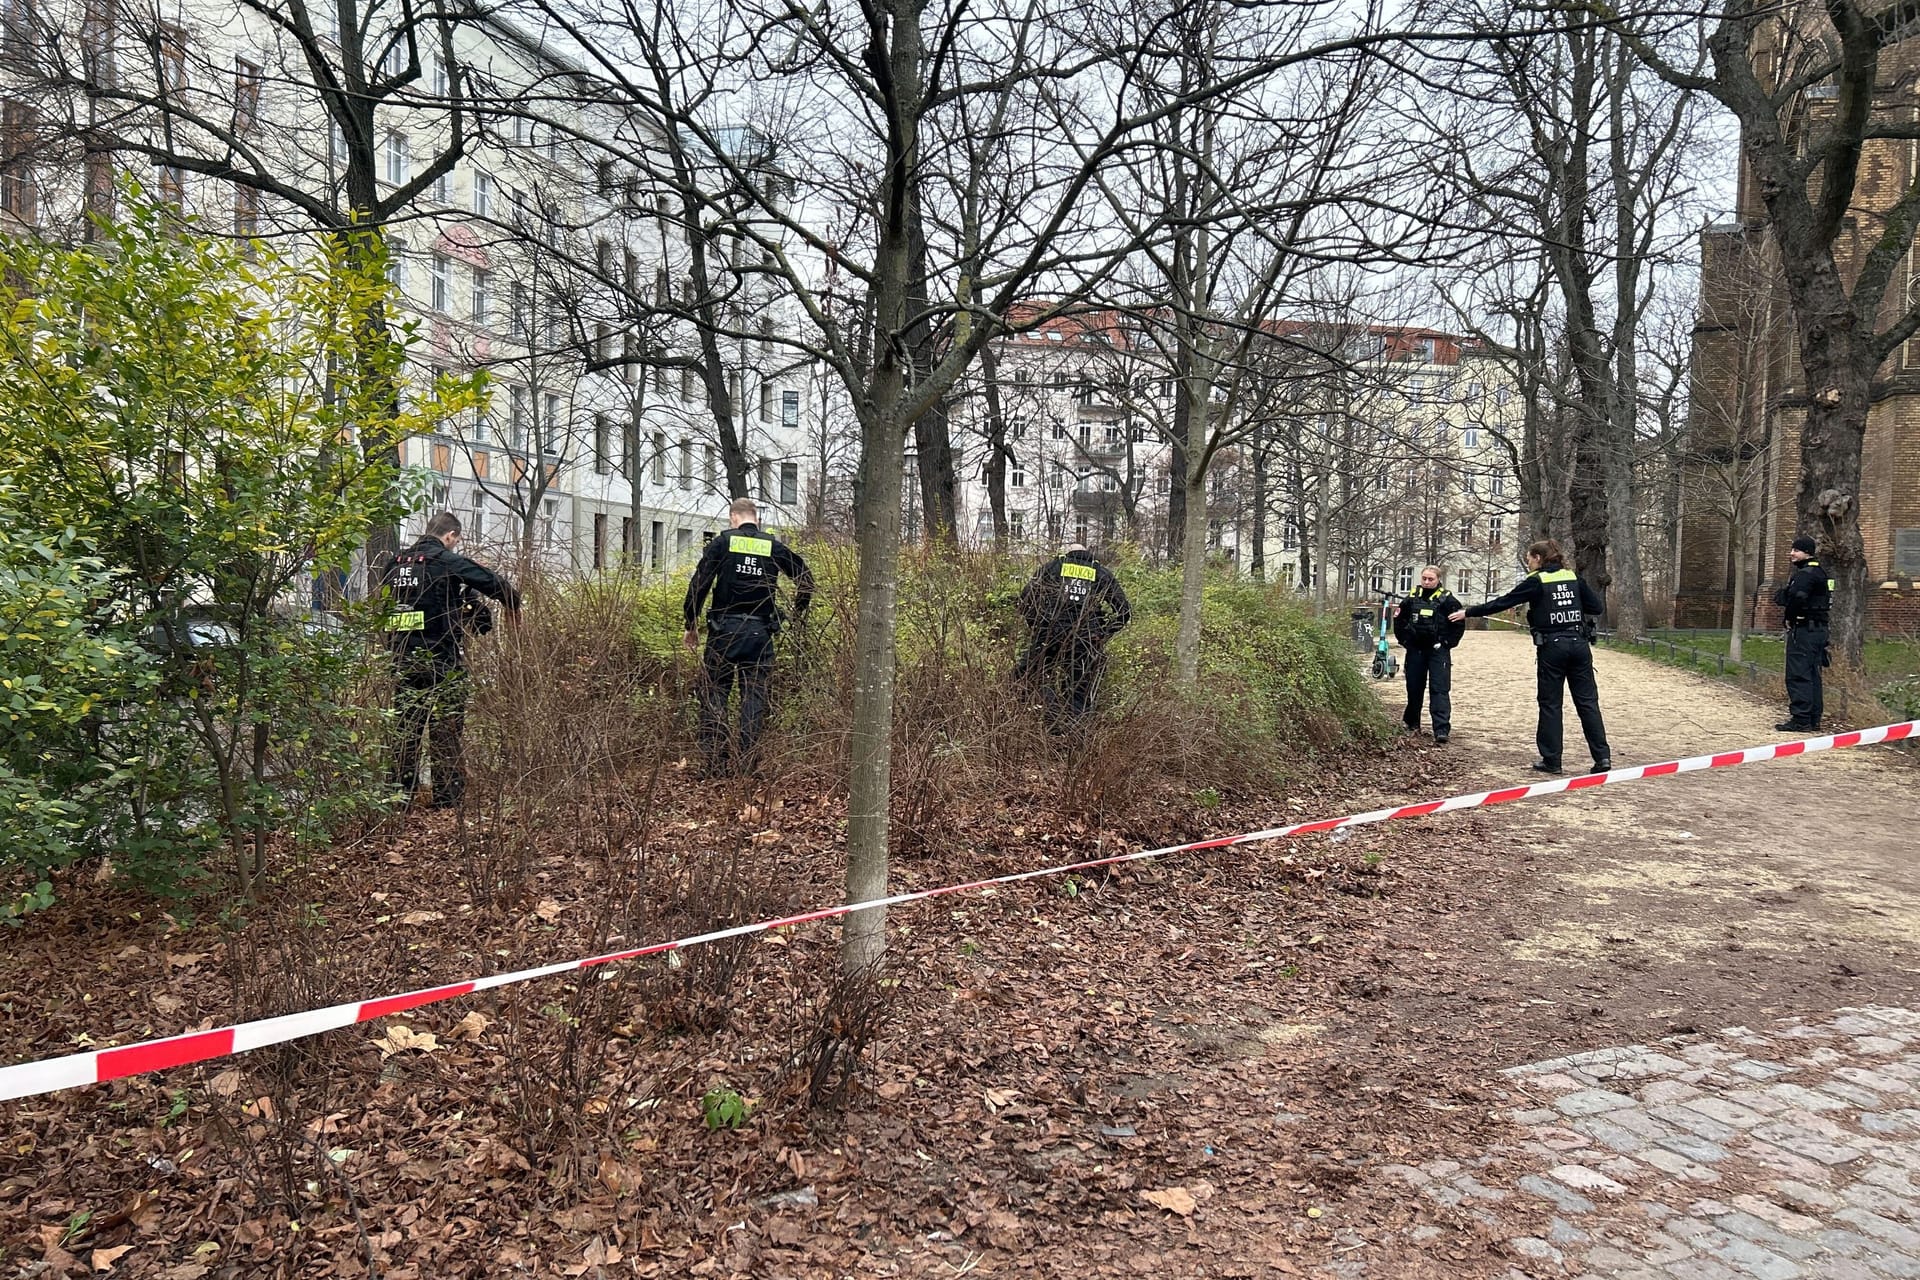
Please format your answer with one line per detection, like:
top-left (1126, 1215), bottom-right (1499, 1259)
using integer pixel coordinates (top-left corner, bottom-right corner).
top-left (0, 720), bottom-right (1920, 1102)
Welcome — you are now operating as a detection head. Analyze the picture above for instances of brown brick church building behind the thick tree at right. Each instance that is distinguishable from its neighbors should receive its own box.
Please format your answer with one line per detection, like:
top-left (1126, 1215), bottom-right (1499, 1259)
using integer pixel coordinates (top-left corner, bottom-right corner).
top-left (1674, 78), bottom-right (1920, 633)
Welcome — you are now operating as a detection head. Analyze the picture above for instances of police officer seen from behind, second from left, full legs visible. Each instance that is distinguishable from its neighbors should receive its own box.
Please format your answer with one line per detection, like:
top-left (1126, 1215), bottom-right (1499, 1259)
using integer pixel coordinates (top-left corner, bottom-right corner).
top-left (684, 497), bottom-right (814, 777)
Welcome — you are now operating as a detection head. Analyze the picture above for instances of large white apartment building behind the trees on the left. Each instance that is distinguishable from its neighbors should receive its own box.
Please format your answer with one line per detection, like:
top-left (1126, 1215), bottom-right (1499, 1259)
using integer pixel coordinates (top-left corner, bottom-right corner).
top-left (0, 0), bottom-right (824, 572)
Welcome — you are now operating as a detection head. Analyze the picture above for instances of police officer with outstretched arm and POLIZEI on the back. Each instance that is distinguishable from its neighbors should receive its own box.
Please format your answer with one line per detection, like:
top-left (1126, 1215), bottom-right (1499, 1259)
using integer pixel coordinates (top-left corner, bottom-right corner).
top-left (1450, 537), bottom-right (1613, 773)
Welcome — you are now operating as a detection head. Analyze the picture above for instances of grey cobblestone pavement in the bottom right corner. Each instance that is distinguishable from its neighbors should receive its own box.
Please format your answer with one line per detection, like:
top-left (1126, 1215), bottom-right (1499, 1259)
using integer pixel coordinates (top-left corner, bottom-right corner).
top-left (1390, 1007), bottom-right (1920, 1280)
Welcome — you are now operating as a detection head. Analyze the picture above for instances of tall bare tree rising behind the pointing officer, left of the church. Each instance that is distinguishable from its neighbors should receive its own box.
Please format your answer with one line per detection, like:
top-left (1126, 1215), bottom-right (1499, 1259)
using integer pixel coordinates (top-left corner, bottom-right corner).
top-left (1446, 2), bottom-right (1697, 635)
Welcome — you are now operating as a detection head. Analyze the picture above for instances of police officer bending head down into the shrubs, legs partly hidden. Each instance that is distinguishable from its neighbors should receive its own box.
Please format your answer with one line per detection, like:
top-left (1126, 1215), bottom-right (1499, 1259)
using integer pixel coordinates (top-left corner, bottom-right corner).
top-left (1014, 543), bottom-right (1133, 733)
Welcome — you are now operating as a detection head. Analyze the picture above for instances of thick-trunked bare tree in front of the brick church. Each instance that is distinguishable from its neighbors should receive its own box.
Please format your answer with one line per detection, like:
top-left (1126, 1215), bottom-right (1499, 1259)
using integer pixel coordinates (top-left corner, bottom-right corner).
top-left (1596, 0), bottom-right (1920, 670)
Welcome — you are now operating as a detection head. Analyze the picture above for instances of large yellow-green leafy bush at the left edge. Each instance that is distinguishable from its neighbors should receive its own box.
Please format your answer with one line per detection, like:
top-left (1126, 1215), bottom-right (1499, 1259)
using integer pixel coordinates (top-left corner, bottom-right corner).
top-left (0, 192), bottom-right (482, 901)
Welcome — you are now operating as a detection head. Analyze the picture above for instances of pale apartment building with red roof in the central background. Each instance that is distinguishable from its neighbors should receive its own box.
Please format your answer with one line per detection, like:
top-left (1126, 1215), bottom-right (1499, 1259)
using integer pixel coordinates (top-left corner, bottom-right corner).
top-left (956, 313), bottom-right (1524, 599)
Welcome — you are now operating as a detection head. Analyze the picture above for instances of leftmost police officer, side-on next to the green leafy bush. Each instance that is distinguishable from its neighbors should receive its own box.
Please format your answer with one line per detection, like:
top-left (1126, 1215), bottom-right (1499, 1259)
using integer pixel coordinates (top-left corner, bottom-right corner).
top-left (380, 510), bottom-right (520, 810)
